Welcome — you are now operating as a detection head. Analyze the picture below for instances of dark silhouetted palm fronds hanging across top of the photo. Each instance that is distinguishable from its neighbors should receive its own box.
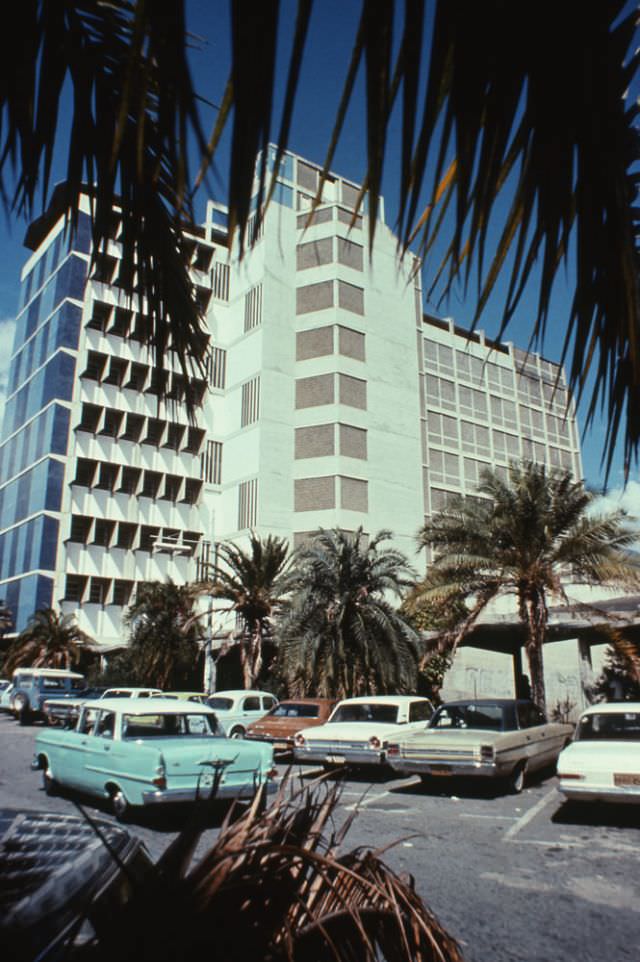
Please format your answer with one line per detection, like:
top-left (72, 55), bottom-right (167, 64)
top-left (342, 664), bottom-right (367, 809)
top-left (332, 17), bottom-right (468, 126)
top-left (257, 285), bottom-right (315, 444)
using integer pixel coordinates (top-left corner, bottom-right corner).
top-left (0, 0), bottom-right (640, 465)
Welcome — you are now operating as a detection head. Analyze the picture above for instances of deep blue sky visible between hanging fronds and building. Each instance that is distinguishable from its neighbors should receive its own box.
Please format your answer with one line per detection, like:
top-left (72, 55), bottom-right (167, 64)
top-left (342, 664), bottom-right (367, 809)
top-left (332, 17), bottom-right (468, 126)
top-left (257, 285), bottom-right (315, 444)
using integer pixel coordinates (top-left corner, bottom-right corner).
top-left (0, 0), bottom-right (640, 515)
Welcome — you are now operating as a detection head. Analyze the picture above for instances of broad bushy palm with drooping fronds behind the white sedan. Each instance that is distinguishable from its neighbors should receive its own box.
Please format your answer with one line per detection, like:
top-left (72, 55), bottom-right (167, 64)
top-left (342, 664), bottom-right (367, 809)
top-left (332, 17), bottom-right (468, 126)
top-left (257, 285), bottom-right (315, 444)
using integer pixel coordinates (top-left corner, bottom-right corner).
top-left (279, 528), bottom-right (418, 698)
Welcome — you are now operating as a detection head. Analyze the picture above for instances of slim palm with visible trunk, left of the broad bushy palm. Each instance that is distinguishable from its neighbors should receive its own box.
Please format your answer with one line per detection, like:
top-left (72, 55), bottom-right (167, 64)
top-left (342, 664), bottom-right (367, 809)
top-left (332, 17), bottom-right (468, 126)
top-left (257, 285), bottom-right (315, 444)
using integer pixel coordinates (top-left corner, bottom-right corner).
top-left (199, 533), bottom-right (290, 688)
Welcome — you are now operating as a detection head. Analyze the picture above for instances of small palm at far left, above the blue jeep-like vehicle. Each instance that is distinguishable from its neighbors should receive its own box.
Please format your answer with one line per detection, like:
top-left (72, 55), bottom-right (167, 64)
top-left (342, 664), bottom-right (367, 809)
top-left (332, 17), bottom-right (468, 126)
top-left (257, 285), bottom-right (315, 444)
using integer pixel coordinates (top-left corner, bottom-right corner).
top-left (4, 608), bottom-right (93, 673)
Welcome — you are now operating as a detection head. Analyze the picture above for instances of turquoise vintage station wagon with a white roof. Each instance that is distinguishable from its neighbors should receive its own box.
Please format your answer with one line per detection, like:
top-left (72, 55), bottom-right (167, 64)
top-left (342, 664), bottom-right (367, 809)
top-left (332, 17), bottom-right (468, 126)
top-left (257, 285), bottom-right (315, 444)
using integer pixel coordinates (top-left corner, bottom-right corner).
top-left (32, 698), bottom-right (275, 819)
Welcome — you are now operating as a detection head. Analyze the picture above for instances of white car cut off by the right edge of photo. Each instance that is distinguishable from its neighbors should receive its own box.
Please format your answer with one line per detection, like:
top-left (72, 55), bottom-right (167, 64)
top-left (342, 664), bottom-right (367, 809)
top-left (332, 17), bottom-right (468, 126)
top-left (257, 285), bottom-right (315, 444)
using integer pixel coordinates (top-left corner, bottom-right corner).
top-left (558, 701), bottom-right (640, 805)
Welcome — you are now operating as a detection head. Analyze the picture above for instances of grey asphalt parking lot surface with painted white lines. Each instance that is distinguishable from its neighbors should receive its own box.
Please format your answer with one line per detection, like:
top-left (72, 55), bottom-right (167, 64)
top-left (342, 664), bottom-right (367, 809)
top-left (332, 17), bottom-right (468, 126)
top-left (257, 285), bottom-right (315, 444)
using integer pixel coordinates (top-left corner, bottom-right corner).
top-left (0, 715), bottom-right (640, 962)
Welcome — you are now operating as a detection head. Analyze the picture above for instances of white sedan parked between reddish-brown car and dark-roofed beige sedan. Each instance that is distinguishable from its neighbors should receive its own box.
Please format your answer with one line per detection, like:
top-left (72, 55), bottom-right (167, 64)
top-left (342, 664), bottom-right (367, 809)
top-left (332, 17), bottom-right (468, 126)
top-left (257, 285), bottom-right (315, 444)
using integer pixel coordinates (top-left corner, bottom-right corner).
top-left (293, 695), bottom-right (433, 768)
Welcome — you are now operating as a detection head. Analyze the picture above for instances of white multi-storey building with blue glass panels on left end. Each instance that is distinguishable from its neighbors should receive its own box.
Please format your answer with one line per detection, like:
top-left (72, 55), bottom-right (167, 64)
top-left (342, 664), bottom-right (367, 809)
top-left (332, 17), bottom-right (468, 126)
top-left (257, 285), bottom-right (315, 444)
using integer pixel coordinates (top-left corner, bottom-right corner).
top-left (0, 146), bottom-right (582, 650)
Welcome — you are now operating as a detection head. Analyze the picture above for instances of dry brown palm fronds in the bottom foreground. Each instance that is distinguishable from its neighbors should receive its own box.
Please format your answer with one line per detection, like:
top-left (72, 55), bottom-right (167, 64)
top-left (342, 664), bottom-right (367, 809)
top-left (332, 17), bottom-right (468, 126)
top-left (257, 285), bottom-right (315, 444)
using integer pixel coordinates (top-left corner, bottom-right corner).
top-left (83, 779), bottom-right (462, 962)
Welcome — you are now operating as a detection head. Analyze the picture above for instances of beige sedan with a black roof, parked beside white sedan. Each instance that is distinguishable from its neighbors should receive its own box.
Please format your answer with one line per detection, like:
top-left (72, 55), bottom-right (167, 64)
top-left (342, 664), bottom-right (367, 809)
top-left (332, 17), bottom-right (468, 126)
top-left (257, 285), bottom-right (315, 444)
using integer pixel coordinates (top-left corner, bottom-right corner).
top-left (387, 698), bottom-right (573, 794)
